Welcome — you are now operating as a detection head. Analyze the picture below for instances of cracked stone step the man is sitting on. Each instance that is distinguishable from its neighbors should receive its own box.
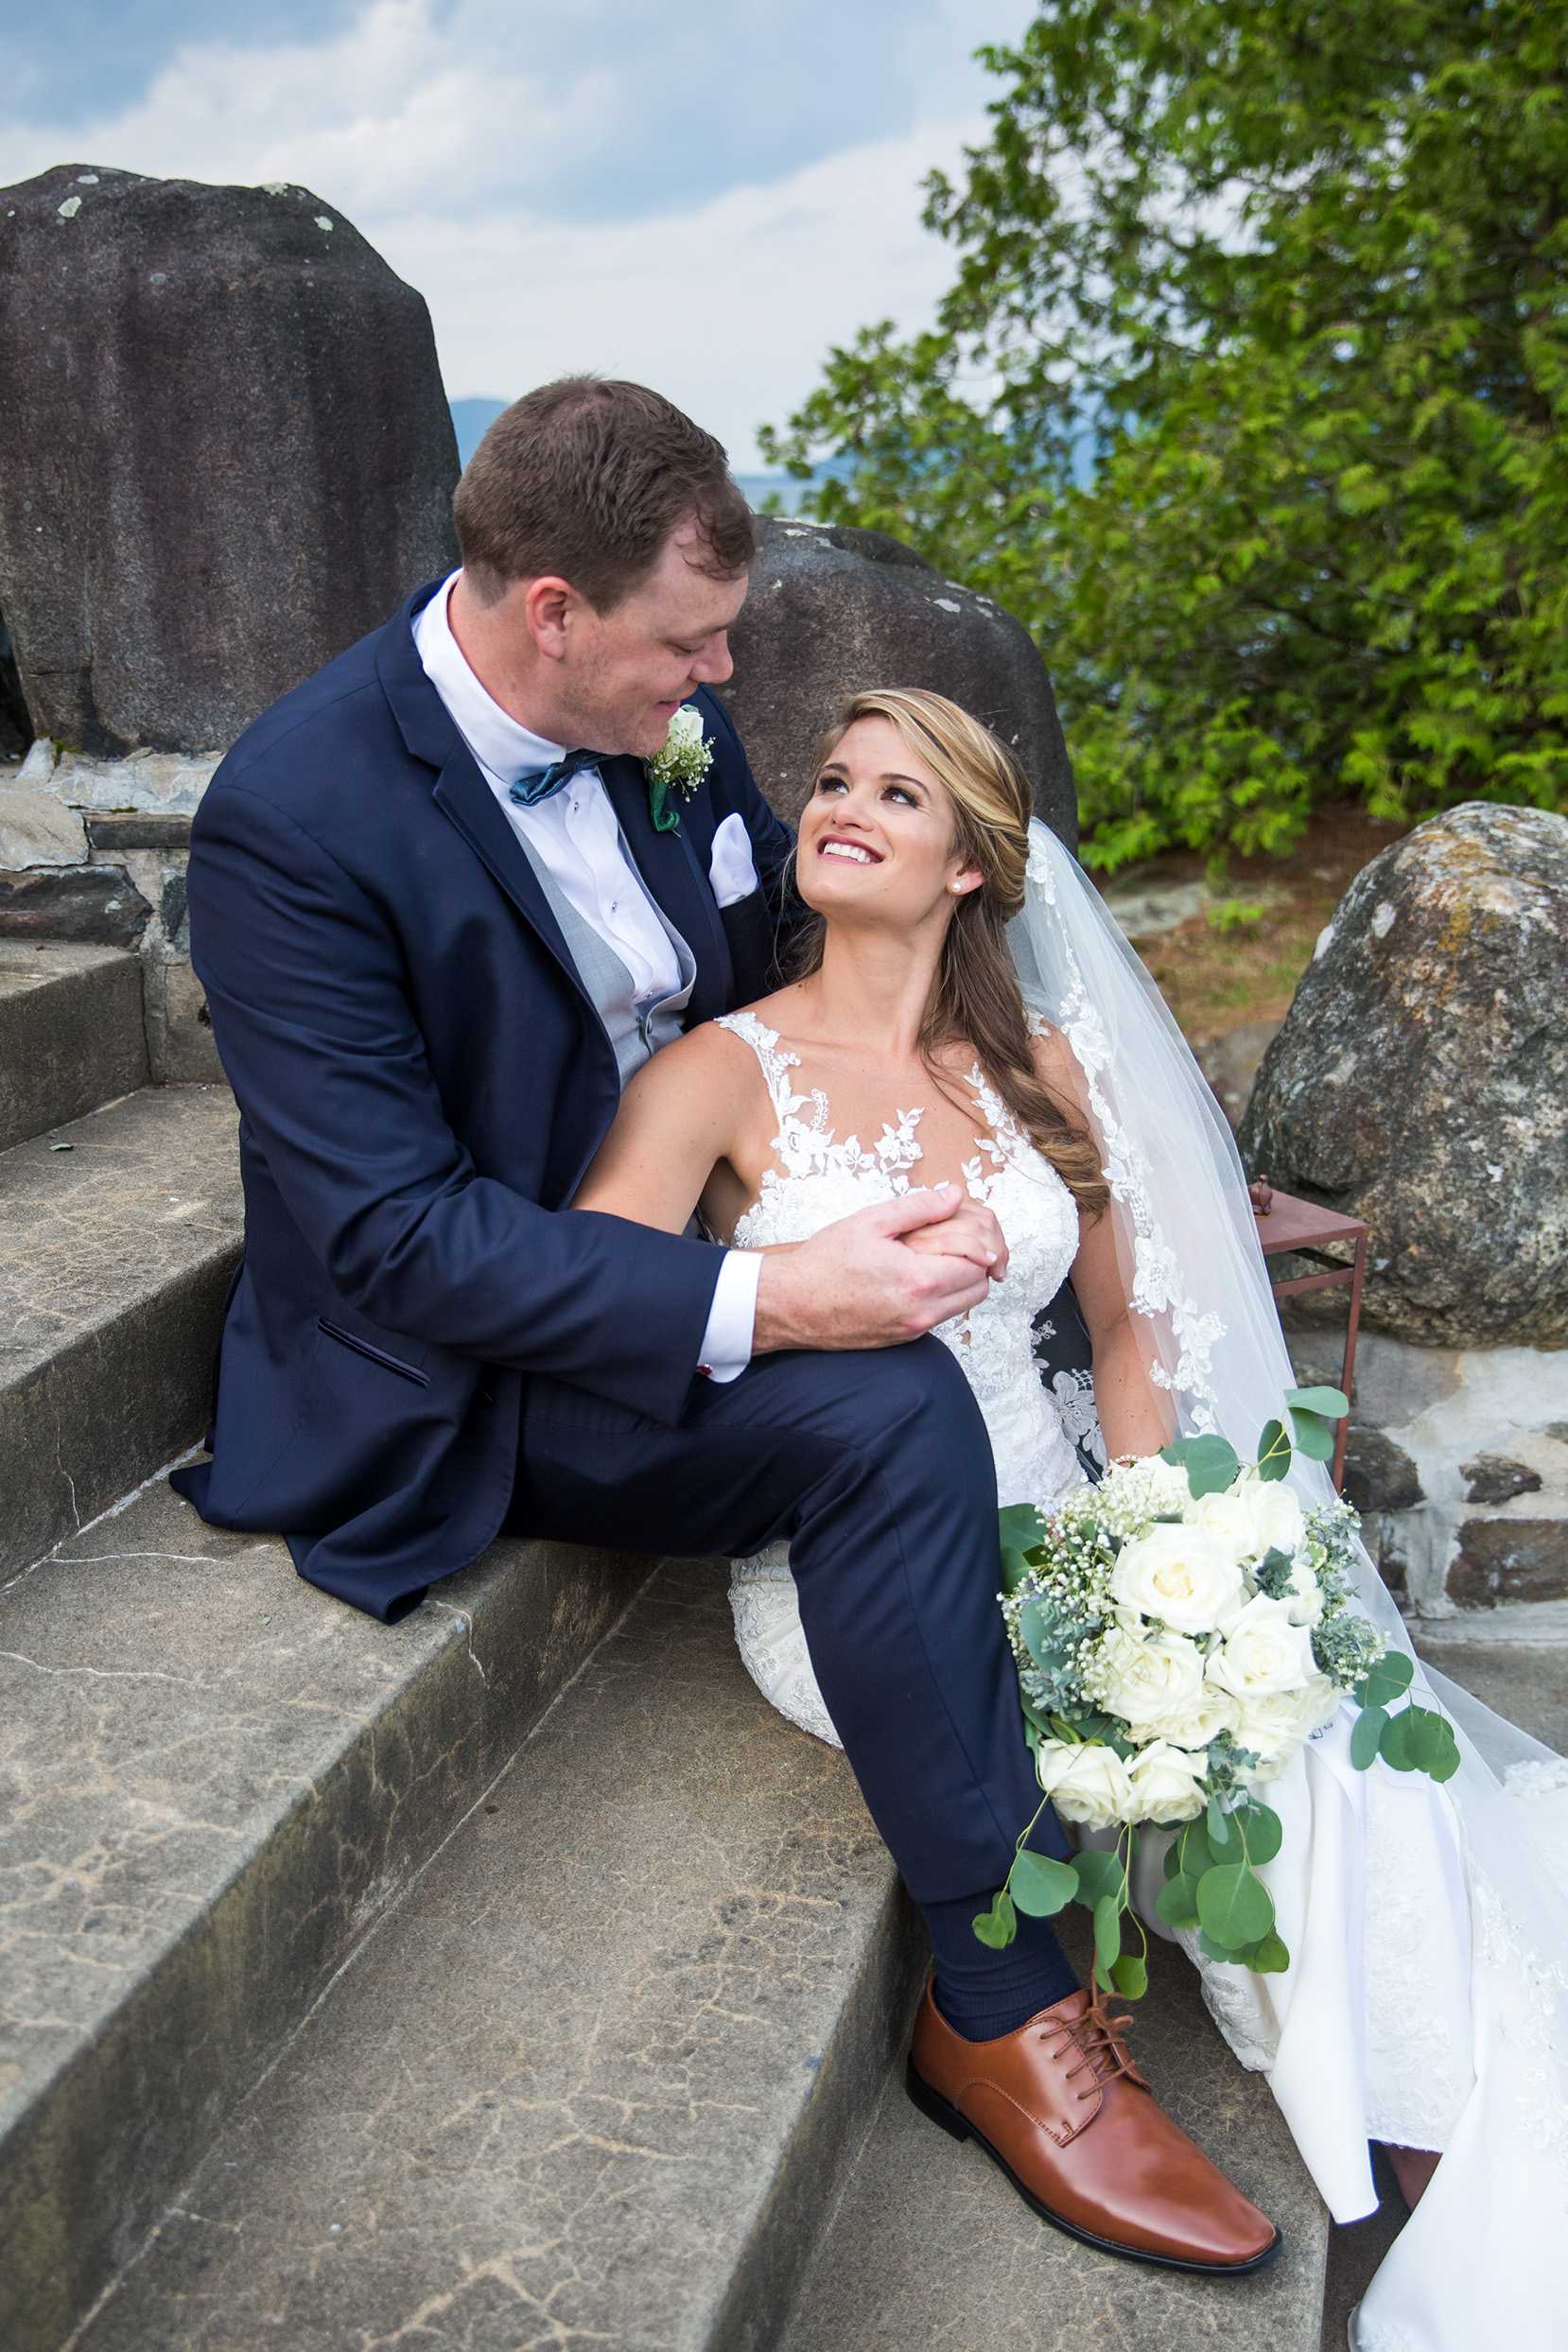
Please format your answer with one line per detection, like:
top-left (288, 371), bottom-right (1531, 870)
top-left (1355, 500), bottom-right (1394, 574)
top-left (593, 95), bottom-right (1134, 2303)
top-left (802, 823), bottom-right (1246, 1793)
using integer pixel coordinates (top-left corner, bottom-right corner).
top-left (0, 1482), bottom-right (652, 2352)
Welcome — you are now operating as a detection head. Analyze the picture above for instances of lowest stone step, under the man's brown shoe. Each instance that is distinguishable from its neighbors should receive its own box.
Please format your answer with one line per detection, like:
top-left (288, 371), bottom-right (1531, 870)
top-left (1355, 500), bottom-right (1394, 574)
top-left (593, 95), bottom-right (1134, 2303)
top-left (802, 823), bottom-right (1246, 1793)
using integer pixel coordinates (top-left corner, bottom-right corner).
top-left (780, 1905), bottom-right (1328, 2352)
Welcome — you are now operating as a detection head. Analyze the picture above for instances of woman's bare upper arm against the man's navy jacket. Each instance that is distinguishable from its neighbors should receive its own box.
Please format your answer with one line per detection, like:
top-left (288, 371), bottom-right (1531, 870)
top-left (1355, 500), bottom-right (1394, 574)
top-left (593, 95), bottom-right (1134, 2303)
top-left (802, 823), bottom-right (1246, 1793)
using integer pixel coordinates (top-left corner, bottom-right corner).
top-left (571, 1025), bottom-right (750, 1232)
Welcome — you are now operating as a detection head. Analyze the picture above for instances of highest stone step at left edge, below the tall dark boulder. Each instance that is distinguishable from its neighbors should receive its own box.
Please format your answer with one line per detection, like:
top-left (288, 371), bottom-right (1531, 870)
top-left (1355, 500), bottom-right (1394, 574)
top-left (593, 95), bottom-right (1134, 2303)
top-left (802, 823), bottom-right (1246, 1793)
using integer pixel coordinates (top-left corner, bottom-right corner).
top-left (0, 938), bottom-right (148, 1150)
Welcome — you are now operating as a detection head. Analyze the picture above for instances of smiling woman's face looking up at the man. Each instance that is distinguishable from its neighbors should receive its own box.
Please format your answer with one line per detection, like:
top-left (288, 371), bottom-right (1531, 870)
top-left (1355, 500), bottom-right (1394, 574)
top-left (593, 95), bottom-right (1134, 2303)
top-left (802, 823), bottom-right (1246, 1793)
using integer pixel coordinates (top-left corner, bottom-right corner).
top-left (794, 720), bottom-right (983, 932)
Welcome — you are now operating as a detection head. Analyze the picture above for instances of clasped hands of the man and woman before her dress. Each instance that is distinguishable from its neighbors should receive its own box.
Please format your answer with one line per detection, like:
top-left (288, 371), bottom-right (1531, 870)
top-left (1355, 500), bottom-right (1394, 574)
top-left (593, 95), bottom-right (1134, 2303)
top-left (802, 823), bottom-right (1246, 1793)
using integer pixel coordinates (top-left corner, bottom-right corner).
top-left (752, 1183), bottom-right (1006, 1355)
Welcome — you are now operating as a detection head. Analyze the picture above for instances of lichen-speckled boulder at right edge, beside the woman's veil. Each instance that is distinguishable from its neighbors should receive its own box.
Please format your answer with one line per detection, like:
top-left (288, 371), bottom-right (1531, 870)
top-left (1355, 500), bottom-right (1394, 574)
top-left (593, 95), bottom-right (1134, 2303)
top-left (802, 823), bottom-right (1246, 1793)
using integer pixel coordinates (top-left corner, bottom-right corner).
top-left (1241, 802), bottom-right (1568, 1348)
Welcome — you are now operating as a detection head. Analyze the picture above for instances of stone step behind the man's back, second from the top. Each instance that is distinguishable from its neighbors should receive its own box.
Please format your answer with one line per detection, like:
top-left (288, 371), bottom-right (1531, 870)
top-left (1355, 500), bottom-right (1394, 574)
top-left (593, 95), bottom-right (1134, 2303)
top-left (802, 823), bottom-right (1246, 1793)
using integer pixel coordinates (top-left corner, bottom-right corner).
top-left (0, 1087), bottom-right (242, 1571)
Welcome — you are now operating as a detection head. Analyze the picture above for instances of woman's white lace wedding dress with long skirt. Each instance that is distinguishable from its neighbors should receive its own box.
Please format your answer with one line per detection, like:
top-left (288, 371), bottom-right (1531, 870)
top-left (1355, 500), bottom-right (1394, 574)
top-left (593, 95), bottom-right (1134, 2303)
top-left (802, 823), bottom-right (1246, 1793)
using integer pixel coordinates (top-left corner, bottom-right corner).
top-left (722, 1014), bottom-right (1568, 2352)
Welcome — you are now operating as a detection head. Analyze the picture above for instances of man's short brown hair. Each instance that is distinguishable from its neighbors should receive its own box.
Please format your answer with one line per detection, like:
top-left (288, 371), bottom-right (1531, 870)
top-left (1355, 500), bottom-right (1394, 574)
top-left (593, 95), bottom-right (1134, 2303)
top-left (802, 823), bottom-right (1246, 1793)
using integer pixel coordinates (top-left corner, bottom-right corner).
top-left (451, 376), bottom-right (757, 612)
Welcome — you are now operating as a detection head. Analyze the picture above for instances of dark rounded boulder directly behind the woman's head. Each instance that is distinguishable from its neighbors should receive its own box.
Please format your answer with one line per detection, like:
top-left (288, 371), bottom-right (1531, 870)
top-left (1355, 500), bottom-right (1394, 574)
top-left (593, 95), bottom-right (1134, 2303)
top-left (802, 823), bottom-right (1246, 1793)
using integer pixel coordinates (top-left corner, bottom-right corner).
top-left (722, 515), bottom-right (1079, 849)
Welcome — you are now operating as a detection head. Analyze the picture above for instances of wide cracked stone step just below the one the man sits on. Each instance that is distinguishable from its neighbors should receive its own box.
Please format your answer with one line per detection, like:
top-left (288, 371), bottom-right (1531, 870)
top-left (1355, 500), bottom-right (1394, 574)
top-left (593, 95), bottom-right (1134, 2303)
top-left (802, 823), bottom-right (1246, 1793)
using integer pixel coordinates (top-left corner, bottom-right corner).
top-left (80, 1561), bottom-right (926, 2352)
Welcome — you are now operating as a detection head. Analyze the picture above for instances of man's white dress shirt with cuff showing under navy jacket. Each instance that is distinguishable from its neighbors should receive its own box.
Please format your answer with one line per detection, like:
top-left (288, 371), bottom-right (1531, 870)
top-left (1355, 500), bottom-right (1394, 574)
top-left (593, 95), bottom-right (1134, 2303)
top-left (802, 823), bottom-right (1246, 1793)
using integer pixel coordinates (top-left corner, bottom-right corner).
top-left (413, 571), bottom-right (761, 1381)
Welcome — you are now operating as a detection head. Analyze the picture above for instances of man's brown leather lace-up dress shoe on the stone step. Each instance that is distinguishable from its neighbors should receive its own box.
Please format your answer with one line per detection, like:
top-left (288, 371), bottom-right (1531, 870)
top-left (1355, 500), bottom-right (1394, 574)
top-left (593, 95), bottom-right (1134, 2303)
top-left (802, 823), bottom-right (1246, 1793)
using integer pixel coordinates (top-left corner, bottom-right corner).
top-left (908, 1985), bottom-right (1283, 2279)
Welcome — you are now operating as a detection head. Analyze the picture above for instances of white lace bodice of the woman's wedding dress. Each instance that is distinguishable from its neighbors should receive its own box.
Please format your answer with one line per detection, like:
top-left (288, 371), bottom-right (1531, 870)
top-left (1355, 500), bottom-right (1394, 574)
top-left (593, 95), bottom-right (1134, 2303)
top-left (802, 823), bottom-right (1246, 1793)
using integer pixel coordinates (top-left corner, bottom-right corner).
top-left (720, 1011), bottom-right (1084, 1503)
